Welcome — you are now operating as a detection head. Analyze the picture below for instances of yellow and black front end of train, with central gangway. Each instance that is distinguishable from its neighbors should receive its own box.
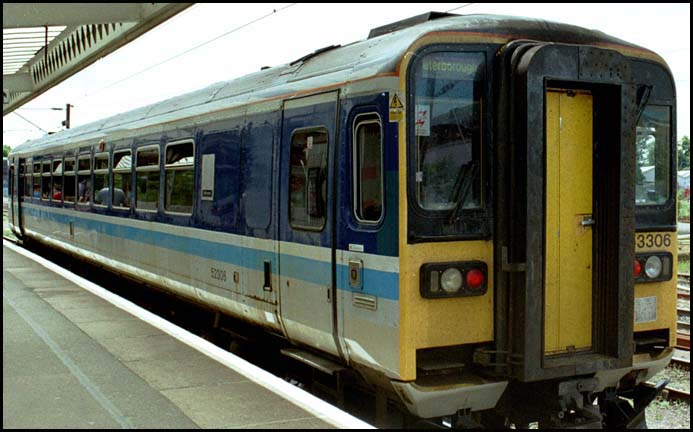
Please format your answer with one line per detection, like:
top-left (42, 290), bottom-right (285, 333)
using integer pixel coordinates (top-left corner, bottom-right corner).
top-left (393, 34), bottom-right (676, 427)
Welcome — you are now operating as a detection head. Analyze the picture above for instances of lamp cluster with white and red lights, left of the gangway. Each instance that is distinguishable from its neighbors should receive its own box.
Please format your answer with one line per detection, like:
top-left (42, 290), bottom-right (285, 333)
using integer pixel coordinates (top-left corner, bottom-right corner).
top-left (419, 261), bottom-right (488, 298)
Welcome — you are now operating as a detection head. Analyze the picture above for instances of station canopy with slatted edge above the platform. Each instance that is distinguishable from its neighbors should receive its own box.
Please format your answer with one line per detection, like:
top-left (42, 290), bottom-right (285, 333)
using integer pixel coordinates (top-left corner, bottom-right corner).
top-left (2, 3), bottom-right (193, 116)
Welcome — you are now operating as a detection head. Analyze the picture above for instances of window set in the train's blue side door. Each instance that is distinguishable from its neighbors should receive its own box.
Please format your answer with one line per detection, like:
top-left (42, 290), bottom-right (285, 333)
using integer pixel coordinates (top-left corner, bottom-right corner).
top-left (289, 128), bottom-right (328, 231)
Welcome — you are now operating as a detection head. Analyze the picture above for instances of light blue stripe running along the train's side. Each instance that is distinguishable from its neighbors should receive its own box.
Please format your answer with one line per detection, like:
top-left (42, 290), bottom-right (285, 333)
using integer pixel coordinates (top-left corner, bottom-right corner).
top-left (23, 206), bottom-right (399, 301)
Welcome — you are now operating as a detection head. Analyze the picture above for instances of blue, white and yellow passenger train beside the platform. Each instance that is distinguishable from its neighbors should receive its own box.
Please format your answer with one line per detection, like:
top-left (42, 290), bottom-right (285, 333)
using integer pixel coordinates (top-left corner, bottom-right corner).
top-left (9, 12), bottom-right (677, 428)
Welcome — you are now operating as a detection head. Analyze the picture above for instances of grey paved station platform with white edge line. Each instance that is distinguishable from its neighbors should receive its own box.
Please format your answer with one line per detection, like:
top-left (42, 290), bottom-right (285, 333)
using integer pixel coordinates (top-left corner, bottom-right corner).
top-left (2, 242), bottom-right (372, 429)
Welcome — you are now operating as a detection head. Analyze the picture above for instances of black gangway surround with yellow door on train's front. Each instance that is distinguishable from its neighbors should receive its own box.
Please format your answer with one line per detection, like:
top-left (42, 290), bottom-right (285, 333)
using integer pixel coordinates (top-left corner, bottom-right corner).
top-left (494, 41), bottom-right (639, 381)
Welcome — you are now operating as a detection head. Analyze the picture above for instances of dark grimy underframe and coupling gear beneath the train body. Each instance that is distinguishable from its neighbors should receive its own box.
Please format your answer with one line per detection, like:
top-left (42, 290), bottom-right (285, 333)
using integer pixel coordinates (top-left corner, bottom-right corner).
top-left (16, 238), bottom-right (674, 429)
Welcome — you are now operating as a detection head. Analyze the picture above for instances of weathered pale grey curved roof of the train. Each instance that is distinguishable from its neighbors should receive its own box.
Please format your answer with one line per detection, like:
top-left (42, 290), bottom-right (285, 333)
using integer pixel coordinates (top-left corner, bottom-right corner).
top-left (12, 12), bottom-right (665, 155)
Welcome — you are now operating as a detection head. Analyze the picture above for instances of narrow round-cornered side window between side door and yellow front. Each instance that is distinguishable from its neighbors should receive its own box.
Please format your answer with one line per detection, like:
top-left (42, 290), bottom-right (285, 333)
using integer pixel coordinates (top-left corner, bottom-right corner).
top-left (353, 114), bottom-right (384, 223)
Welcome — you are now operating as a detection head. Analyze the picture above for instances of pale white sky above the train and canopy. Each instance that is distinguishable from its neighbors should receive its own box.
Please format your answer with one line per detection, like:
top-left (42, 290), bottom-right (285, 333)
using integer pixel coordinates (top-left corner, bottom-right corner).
top-left (2, 3), bottom-right (691, 147)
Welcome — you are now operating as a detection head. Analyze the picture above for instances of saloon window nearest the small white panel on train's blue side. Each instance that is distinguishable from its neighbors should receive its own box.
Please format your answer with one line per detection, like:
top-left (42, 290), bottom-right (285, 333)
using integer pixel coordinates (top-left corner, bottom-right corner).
top-left (164, 141), bottom-right (195, 213)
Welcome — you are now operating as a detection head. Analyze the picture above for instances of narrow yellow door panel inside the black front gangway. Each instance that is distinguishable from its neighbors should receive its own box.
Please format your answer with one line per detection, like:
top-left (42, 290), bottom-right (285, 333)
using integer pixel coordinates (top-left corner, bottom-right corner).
top-left (544, 89), bottom-right (594, 355)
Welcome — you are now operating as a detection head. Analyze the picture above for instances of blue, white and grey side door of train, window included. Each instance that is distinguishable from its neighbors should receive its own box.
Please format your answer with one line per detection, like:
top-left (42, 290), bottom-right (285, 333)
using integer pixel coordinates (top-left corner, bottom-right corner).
top-left (279, 92), bottom-right (339, 355)
